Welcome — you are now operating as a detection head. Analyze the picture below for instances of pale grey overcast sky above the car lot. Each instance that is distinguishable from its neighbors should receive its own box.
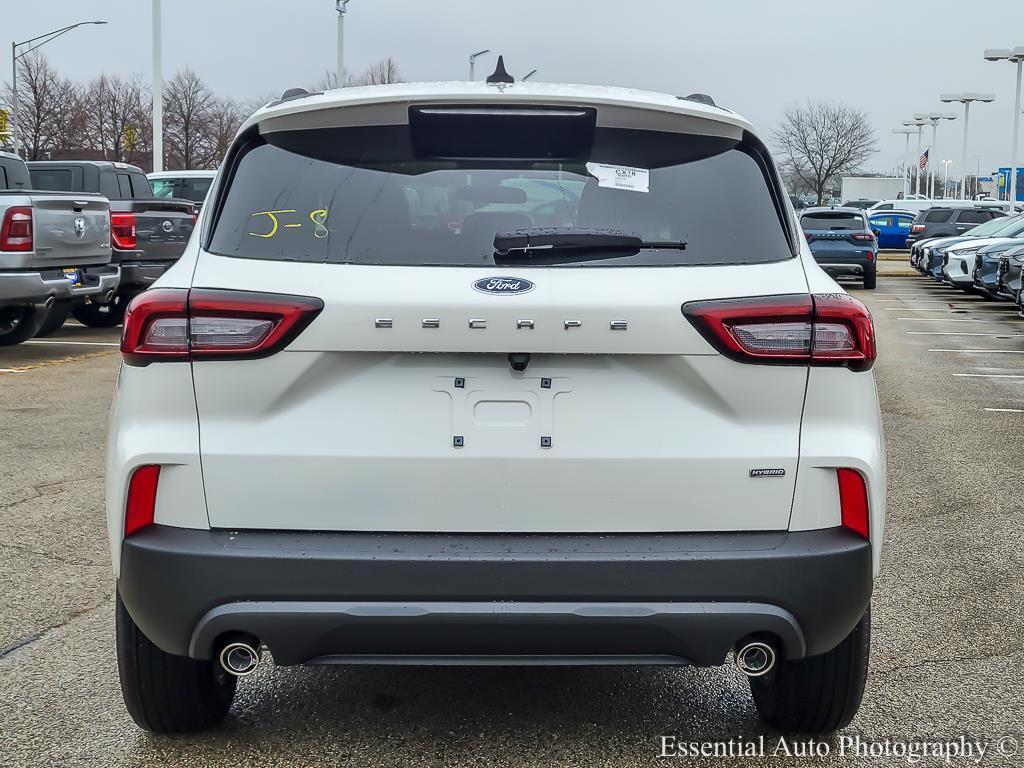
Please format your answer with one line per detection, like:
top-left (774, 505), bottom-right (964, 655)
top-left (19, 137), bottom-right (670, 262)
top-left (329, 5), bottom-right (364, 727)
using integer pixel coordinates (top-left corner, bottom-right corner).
top-left (6, 0), bottom-right (1024, 182)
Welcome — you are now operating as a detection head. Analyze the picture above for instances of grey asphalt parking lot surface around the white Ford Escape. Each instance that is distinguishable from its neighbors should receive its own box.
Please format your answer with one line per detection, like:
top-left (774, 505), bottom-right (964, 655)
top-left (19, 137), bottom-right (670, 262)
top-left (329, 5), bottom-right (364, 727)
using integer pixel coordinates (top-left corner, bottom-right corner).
top-left (0, 278), bottom-right (1024, 767)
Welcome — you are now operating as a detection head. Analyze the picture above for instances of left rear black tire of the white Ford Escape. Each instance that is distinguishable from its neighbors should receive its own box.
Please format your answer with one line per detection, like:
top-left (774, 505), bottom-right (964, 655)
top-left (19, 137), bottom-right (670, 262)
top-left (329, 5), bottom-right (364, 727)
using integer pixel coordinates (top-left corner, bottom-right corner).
top-left (116, 595), bottom-right (237, 733)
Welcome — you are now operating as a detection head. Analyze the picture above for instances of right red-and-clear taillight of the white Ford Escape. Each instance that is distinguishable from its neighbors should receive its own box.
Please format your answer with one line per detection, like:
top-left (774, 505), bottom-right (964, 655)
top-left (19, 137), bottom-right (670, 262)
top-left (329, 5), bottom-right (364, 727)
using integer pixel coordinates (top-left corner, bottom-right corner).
top-left (683, 294), bottom-right (876, 371)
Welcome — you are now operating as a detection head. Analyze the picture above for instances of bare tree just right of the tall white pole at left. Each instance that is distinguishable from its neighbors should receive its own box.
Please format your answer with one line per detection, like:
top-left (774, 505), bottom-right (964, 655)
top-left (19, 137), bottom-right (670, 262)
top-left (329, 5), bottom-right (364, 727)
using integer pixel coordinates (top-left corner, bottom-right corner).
top-left (164, 69), bottom-right (217, 169)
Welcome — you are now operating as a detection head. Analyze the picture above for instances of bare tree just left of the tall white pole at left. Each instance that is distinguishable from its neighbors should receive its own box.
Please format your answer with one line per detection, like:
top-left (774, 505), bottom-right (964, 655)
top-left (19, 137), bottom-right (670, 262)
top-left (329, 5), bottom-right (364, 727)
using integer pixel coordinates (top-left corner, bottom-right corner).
top-left (83, 75), bottom-right (148, 163)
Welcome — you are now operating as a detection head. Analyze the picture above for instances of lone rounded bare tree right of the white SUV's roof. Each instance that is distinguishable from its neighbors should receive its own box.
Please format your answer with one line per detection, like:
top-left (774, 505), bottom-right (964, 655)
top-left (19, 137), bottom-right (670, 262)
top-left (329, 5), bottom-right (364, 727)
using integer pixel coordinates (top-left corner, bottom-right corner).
top-left (772, 101), bottom-right (878, 202)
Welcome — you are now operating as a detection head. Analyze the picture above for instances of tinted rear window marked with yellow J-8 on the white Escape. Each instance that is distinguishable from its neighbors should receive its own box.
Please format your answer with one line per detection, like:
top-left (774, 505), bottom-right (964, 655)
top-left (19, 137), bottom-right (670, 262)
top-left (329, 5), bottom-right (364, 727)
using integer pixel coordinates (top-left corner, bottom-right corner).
top-left (209, 125), bottom-right (793, 266)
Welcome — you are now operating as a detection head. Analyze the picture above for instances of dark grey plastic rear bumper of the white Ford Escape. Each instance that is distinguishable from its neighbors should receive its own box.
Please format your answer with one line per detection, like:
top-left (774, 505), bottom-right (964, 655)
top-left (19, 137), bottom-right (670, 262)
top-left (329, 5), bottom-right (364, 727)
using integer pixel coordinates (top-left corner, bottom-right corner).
top-left (118, 525), bottom-right (871, 666)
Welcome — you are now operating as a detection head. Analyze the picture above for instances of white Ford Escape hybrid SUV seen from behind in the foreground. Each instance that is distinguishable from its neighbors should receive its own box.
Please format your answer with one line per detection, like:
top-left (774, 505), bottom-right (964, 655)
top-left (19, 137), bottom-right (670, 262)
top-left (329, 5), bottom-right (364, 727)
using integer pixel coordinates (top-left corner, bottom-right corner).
top-left (106, 82), bottom-right (886, 732)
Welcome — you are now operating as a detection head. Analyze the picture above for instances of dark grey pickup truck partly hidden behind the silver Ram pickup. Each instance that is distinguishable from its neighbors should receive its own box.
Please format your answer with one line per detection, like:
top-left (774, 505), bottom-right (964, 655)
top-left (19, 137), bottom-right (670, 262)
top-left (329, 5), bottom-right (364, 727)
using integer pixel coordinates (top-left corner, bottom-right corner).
top-left (29, 160), bottom-right (196, 328)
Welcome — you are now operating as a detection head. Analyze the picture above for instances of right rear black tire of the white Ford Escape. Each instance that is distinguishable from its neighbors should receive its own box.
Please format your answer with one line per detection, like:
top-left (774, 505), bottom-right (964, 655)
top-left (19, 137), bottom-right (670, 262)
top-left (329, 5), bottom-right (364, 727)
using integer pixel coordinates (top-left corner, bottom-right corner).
top-left (750, 608), bottom-right (871, 734)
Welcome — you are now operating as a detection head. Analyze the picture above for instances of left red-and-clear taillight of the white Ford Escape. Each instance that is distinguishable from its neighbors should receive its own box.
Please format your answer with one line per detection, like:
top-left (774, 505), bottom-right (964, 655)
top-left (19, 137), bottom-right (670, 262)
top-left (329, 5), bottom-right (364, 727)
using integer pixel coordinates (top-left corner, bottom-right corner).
top-left (121, 288), bottom-right (324, 366)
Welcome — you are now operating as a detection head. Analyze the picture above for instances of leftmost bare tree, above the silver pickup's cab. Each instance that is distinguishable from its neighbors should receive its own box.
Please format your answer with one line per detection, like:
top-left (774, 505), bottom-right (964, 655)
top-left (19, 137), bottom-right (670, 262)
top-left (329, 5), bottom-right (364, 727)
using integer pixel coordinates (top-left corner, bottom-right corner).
top-left (5, 53), bottom-right (85, 160)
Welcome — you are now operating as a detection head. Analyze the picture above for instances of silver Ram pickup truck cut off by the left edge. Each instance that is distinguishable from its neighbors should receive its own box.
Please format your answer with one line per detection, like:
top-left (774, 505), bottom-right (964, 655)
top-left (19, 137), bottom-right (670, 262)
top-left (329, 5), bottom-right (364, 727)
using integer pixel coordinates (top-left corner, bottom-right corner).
top-left (0, 152), bottom-right (120, 346)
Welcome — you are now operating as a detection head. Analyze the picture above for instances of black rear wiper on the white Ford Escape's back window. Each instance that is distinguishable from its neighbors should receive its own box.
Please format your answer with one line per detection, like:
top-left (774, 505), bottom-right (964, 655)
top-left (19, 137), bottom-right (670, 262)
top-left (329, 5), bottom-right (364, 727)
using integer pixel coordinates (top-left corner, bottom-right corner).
top-left (495, 228), bottom-right (686, 260)
